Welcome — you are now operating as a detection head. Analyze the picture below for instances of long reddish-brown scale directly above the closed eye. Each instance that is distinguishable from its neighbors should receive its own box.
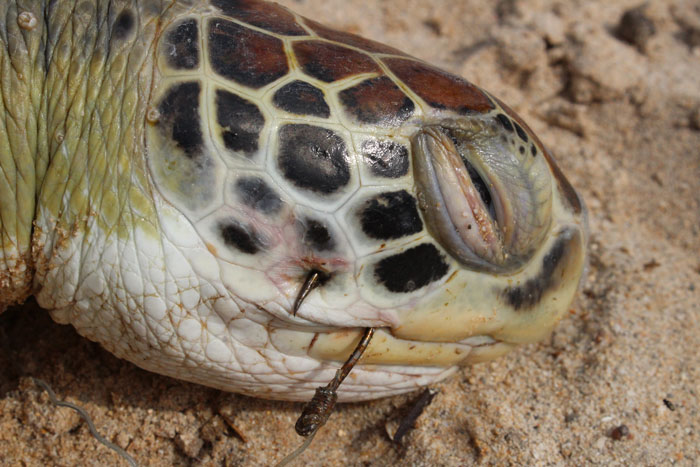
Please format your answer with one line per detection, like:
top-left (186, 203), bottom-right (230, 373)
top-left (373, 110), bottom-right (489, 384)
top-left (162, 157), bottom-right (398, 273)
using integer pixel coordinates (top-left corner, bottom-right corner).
top-left (384, 58), bottom-right (494, 114)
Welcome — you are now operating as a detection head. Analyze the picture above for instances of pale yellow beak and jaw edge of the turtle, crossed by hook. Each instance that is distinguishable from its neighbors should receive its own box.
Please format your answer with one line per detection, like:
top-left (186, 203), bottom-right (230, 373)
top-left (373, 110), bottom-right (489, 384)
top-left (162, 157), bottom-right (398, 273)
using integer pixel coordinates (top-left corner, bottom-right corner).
top-left (271, 223), bottom-right (586, 368)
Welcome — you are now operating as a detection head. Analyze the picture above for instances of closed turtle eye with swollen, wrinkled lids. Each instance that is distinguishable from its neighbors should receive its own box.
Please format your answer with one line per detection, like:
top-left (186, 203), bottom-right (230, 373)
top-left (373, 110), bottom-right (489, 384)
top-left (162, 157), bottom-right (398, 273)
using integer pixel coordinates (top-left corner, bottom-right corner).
top-left (412, 114), bottom-right (552, 273)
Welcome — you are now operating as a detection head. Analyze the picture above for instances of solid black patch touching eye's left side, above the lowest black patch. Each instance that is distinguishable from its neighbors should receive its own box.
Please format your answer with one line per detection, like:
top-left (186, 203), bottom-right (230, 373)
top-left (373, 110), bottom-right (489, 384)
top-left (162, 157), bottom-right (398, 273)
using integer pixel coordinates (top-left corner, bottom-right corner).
top-left (358, 190), bottom-right (423, 240)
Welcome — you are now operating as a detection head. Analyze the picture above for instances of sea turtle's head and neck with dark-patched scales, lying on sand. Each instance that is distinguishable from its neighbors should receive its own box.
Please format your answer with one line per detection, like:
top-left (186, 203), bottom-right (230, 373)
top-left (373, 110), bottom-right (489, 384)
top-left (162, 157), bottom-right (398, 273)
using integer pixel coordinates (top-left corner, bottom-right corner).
top-left (0, 0), bottom-right (587, 401)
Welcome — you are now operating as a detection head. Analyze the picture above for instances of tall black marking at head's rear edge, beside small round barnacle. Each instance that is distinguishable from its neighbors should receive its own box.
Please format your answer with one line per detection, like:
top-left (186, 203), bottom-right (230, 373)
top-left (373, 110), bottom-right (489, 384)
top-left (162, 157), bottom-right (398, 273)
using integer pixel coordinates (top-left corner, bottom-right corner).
top-left (158, 81), bottom-right (204, 158)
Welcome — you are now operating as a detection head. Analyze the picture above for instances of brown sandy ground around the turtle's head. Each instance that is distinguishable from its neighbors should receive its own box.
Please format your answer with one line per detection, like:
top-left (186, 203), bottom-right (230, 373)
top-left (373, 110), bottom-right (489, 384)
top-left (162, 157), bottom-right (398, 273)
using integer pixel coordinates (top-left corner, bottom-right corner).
top-left (0, 0), bottom-right (700, 465)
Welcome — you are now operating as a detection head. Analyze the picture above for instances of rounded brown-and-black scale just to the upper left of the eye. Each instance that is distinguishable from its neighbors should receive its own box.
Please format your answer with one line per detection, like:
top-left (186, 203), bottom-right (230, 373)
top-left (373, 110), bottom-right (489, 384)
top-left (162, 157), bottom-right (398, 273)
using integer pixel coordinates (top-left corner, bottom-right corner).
top-left (339, 76), bottom-right (415, 127)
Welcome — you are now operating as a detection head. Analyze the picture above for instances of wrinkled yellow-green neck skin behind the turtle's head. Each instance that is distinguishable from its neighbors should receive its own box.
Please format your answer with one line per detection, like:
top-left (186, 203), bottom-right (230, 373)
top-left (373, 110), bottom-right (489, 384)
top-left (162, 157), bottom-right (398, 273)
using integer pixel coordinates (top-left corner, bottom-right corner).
top-left (0, 0), bottom-right (182, 311)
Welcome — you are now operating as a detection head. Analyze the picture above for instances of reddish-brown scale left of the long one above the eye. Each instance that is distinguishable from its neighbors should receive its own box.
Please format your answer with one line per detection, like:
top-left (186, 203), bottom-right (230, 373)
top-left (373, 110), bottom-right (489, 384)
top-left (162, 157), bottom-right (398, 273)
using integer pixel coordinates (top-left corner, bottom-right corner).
top-left (293, 41), bottom-right (381, 83)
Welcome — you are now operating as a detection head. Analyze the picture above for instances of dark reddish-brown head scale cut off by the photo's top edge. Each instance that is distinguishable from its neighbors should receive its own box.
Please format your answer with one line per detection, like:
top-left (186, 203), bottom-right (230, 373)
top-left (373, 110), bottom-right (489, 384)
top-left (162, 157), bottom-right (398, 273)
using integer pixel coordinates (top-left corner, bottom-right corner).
top-left (211, 0), bottom-right (306, 36)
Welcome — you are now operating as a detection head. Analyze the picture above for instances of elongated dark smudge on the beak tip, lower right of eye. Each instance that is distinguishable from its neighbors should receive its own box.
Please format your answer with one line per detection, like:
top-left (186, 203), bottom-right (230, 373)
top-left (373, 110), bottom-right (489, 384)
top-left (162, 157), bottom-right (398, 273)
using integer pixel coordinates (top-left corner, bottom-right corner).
top-left (505, 235), bottom-right (571, 311)
